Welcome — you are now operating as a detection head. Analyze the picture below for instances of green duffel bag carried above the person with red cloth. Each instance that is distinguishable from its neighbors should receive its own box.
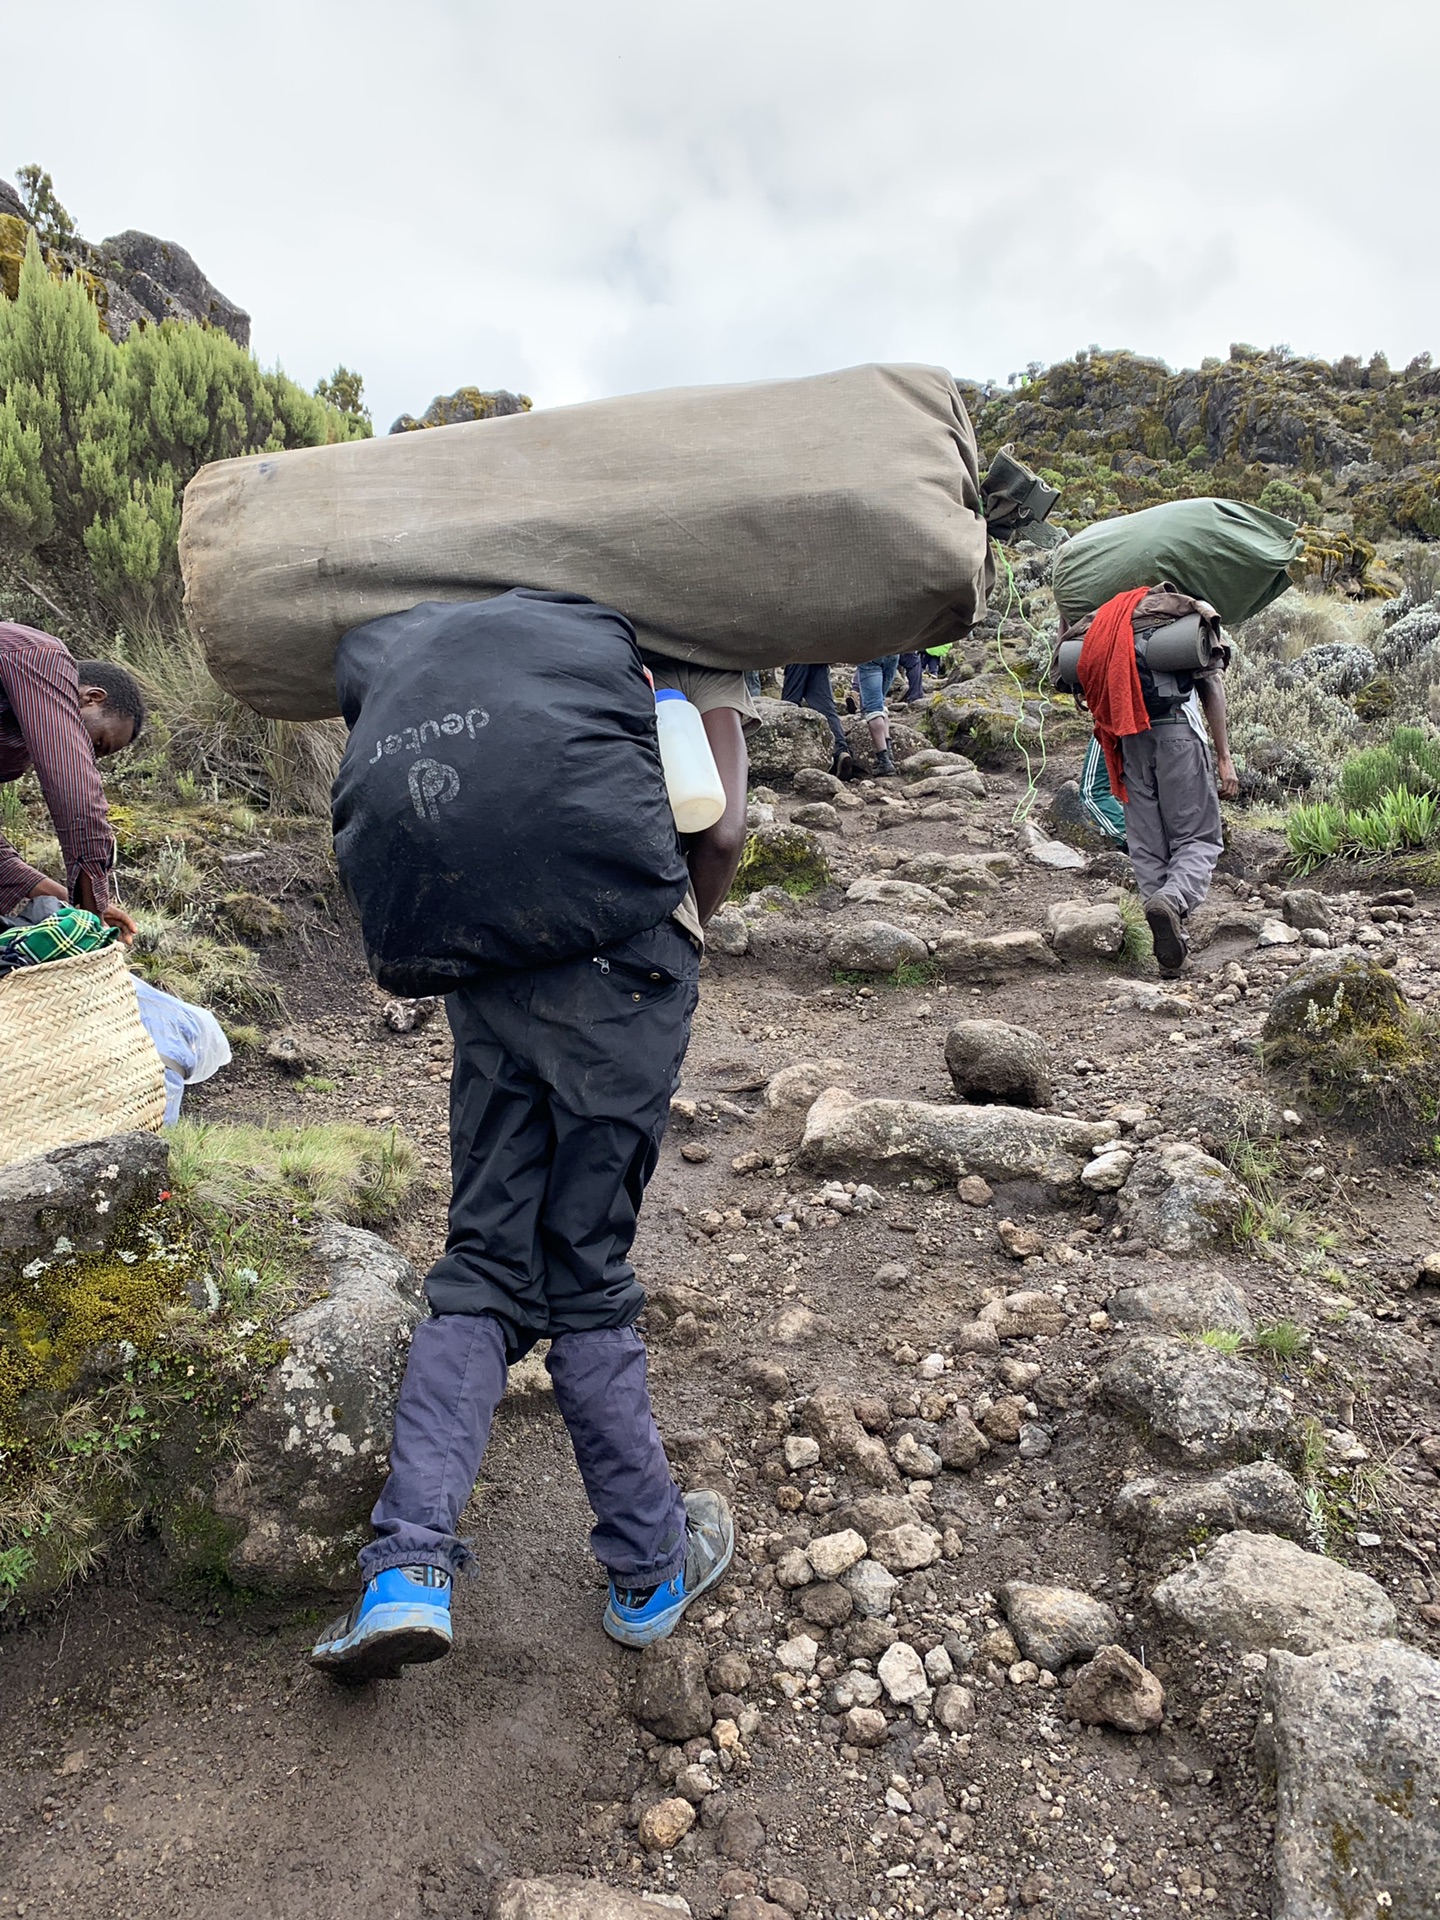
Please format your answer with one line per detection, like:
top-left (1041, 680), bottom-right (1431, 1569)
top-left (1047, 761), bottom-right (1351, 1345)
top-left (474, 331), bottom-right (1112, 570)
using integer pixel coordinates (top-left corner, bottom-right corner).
top-left (1052, 499), bottom-right (1304, 622)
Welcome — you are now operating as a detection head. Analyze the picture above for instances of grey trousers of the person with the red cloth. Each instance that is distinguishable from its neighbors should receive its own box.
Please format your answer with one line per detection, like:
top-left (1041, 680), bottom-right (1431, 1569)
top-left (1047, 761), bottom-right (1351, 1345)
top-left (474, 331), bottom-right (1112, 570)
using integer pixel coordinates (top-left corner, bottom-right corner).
top-left (1119, 720), bottom-right (1225, 914)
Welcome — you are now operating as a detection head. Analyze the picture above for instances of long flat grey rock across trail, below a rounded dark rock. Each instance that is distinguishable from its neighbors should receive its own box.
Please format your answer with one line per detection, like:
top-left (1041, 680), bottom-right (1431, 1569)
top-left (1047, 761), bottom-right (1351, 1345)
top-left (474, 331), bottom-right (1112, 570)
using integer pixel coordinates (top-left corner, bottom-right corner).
top-left (799, 1087), bottom-right (1119, 1188)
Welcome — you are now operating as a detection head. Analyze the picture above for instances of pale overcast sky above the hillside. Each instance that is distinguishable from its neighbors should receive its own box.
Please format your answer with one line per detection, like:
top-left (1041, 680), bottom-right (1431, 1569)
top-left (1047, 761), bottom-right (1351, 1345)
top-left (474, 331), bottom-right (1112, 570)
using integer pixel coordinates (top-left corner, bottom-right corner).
top-left (11, 0), bottom-right (1440, 430)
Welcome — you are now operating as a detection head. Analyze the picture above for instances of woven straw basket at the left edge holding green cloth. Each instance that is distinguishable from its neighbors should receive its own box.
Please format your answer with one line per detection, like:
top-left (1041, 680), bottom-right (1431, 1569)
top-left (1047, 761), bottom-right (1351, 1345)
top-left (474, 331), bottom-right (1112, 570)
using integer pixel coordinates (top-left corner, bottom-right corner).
top-left (0, 945), bottom-right (165, 1167)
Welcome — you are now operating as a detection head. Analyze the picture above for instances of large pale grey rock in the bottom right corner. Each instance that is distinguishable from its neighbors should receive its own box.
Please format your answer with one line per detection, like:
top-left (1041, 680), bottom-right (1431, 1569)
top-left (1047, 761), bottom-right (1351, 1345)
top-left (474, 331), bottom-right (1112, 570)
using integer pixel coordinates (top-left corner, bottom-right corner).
top-left (1261, 1640), bottom-right (1440, 1920)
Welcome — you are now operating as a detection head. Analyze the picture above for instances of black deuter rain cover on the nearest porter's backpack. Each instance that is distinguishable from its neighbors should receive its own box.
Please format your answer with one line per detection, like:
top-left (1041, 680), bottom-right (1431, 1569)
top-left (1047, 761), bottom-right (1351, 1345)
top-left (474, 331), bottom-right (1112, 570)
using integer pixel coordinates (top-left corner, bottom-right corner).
top-left (334, 588), bottom-right (689, 995)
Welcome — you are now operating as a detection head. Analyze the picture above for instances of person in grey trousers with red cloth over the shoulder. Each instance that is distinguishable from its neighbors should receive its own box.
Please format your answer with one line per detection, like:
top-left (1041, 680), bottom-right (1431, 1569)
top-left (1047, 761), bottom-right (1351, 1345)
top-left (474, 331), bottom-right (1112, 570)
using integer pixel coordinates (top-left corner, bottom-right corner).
top-left (1060, 586), bottom-right (1240, 973)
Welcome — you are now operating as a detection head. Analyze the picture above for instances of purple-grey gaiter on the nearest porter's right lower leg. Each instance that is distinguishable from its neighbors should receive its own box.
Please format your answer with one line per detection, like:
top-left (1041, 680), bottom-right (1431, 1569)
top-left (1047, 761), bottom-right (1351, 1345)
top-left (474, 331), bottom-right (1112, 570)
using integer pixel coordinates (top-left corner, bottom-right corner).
top-left (545, 1327), bottom-right (685, 1588)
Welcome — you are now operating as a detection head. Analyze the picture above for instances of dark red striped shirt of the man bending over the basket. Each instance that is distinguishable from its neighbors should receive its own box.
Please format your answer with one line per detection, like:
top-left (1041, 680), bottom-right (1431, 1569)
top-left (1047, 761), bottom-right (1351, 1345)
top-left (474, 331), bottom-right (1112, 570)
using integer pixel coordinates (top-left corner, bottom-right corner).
top-left (0, 620), bottom-right (115, 914)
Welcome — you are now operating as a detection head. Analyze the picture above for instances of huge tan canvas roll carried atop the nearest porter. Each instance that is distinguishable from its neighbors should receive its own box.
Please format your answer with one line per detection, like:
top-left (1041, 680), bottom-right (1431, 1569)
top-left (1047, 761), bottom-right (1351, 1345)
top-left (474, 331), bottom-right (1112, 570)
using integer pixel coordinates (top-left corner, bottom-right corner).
top-left (180, 367), bottom-right (989, 720)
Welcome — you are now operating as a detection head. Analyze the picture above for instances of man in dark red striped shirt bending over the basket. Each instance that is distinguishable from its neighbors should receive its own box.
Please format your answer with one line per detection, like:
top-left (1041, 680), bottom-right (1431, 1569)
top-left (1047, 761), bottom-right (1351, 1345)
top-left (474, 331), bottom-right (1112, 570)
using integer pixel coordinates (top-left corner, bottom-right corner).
top-left (0, 620), bottom-right (146, 943)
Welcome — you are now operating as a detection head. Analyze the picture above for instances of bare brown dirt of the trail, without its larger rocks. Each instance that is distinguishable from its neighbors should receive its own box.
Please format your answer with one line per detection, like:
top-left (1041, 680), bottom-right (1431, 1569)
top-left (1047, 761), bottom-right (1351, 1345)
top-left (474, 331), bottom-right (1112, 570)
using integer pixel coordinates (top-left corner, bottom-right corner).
top-left (0, 744), bottom-right (1440, 1920)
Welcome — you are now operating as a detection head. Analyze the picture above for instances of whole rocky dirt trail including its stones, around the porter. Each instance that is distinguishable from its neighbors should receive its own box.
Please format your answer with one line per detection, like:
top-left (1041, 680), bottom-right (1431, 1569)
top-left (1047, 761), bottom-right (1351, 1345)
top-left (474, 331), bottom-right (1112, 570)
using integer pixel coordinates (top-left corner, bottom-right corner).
top-left (0, 710), bottom-right (1440, 1920)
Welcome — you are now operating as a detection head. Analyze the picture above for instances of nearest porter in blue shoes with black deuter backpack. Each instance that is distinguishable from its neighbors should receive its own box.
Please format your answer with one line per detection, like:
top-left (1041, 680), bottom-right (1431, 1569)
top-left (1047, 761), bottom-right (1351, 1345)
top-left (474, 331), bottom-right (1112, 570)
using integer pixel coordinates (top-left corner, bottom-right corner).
top-left (311, 589), bottom-right (758, 1680)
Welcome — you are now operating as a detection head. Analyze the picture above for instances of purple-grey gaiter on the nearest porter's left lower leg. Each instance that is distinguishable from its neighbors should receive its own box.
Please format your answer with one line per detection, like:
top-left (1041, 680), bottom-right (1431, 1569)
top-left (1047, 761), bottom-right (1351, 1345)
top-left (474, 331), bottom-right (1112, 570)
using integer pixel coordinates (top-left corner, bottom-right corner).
top-left (359, 1313), bottom-right (505, 1580)
